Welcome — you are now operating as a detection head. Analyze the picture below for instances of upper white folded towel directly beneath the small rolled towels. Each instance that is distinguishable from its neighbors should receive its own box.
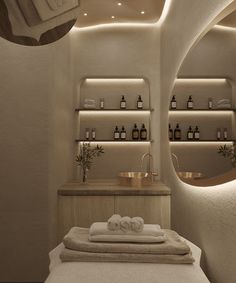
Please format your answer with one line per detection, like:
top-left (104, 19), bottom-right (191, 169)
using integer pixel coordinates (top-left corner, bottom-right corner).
top-left (89, 222), bottom-right (165, 237)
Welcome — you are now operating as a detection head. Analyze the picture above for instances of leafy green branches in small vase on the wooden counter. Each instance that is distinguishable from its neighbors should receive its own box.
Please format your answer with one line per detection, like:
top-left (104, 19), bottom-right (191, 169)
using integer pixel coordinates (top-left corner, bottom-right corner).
top-left (76, 142), bottom-right (104, 183)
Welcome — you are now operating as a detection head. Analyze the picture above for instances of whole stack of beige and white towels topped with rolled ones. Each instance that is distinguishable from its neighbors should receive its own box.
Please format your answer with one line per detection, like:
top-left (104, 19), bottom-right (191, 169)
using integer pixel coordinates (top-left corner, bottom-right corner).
top-left (60, 215), bottom-right (194, 263)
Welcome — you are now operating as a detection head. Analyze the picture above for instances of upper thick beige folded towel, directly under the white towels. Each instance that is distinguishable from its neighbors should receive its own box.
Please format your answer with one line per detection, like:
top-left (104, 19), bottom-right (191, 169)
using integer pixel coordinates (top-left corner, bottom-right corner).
top-left (63, 227), bottom-right (190, 254)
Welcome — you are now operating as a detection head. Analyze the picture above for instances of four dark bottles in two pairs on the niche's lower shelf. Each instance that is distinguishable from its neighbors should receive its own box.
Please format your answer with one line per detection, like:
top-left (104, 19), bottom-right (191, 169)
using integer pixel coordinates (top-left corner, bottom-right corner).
top-left (113, 124), bottom-right (147, 140)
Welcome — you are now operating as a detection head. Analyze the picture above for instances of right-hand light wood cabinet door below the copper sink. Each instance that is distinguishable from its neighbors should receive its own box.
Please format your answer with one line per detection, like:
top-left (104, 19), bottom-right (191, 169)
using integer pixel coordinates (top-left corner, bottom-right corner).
top-left (115, 196), bottom-right (170, 229)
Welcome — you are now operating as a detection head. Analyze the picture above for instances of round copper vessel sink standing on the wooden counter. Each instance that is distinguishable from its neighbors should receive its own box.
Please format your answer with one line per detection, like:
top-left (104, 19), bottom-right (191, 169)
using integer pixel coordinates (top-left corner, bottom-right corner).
top-left (118, 172), bottom-right (157, 187)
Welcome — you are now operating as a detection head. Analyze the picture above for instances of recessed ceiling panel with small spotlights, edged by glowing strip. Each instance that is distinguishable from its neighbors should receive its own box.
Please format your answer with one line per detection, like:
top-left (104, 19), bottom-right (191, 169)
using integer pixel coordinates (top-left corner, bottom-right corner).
top-left (75, 0), bottom-right (165, 27)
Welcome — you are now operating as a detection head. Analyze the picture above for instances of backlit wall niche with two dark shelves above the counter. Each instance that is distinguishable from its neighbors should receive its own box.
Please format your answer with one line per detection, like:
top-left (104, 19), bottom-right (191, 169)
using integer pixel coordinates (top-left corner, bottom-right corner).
top-left (75, 78), bottom-right (153, 179)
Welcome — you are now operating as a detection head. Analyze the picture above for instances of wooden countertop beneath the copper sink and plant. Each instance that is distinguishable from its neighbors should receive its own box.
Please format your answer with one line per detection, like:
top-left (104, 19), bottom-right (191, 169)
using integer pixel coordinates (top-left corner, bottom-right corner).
top-left (58, 180), bottom-right (171, 196)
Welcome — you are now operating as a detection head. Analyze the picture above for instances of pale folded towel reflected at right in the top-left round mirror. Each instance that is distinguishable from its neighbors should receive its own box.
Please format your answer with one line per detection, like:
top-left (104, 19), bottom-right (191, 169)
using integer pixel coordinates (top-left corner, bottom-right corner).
top-left (32, 0), bottom-right (78, 21)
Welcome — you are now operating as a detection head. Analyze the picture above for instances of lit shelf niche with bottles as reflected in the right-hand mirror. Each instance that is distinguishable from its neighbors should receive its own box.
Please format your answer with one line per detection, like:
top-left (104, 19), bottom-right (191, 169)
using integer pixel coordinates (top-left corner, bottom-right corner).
top-left (169, 78), bottom-right (236, 143)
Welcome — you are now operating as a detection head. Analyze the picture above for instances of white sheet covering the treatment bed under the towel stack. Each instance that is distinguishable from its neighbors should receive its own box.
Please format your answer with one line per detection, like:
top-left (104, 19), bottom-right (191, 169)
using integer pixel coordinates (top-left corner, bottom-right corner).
top-left (45, 239), bottom-right (209, 283)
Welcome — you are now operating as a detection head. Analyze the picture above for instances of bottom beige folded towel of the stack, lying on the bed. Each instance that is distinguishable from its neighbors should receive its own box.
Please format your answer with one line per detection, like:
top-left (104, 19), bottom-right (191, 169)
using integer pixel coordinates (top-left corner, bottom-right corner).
top-left (60, 248), bottom-right (194, 264)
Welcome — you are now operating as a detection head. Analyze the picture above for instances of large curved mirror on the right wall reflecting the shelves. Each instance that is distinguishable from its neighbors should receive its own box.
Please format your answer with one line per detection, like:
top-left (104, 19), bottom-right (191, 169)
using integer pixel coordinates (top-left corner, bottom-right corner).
top-left (169, 12), bottom-right (236, 186)
